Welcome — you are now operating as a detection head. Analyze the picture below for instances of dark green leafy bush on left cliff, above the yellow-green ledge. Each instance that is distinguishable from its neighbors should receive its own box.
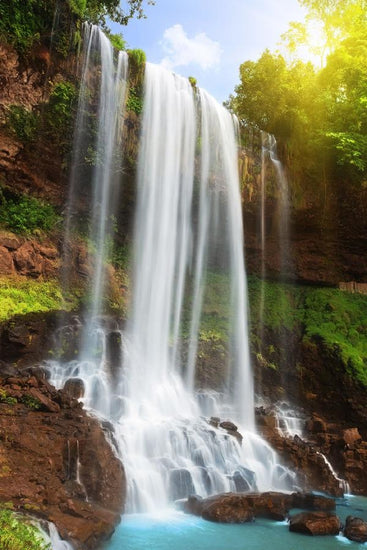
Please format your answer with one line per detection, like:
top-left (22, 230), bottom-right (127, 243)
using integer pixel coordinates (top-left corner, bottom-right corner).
top-left (0, 195), bottom-right (59, 235)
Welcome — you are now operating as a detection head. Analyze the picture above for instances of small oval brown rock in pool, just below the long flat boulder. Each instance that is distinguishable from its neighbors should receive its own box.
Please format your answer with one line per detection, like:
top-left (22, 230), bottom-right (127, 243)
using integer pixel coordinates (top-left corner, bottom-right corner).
top-left (289, 512), bottom-right (340, 536)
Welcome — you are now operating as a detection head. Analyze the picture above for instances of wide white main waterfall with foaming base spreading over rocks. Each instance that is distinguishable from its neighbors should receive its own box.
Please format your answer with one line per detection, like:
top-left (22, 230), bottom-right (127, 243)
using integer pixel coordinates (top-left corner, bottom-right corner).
top-left (50, 34), bottom-right (292, 511)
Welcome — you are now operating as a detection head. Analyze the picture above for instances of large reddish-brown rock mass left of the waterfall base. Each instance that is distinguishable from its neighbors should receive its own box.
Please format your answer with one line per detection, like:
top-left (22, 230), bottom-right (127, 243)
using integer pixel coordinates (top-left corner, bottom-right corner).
top-left (0, 365), bottom-right (125, 550)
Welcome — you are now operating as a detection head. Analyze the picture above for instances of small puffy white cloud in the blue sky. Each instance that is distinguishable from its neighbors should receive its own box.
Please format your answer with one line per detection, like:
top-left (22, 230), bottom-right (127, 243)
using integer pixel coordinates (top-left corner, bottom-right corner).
top-left (161, 25), bottom-right (222, 70)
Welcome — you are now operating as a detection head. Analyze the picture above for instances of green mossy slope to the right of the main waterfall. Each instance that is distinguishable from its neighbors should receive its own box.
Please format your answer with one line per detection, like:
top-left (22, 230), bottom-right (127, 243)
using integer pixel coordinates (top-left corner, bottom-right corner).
top-left (248, 278), bottom-right (367, 386)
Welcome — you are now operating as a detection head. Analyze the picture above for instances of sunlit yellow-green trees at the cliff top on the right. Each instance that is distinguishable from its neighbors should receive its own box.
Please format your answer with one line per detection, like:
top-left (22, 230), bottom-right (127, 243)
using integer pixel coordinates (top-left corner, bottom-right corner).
top-left (228, 0), bottom-right (367, 188)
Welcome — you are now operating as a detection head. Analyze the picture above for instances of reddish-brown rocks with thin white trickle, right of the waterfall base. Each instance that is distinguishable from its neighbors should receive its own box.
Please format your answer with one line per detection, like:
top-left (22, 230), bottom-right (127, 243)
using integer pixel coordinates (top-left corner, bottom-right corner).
top-left (256, 407), bottom-right (367, 496)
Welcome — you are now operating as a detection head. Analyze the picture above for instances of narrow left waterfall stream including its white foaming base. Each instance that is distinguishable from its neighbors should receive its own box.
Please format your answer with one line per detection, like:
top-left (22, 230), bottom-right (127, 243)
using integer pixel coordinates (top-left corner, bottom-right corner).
top-left (53, 24), bottom-right (128, 416)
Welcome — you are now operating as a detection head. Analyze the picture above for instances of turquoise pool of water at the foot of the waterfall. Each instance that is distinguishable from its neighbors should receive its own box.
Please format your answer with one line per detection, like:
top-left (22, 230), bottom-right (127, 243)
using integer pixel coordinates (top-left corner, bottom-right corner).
top-left (106, 496), bottom-right (367, 550)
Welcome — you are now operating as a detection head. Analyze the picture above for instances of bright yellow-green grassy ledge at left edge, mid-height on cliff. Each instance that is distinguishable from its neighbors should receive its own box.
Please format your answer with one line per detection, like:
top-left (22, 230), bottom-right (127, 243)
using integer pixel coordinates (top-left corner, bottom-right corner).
top-left (0, 278), bottom-right (68, 321)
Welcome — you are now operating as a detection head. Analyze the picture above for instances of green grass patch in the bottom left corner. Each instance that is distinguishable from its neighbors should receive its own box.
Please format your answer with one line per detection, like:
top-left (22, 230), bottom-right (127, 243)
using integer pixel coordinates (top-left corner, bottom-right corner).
top-left (0, 510), bottom-right (51, 550)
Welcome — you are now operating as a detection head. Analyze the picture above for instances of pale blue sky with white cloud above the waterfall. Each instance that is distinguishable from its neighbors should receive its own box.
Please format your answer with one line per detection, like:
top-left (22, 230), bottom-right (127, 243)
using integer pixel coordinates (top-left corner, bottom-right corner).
top-left (111, 0), bottom-right (304, 101)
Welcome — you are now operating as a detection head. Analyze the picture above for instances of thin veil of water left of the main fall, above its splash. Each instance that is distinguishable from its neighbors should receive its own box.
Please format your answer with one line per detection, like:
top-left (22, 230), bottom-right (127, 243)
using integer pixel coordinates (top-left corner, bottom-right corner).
top-left (64, 24), bottom-right (128, 314)
